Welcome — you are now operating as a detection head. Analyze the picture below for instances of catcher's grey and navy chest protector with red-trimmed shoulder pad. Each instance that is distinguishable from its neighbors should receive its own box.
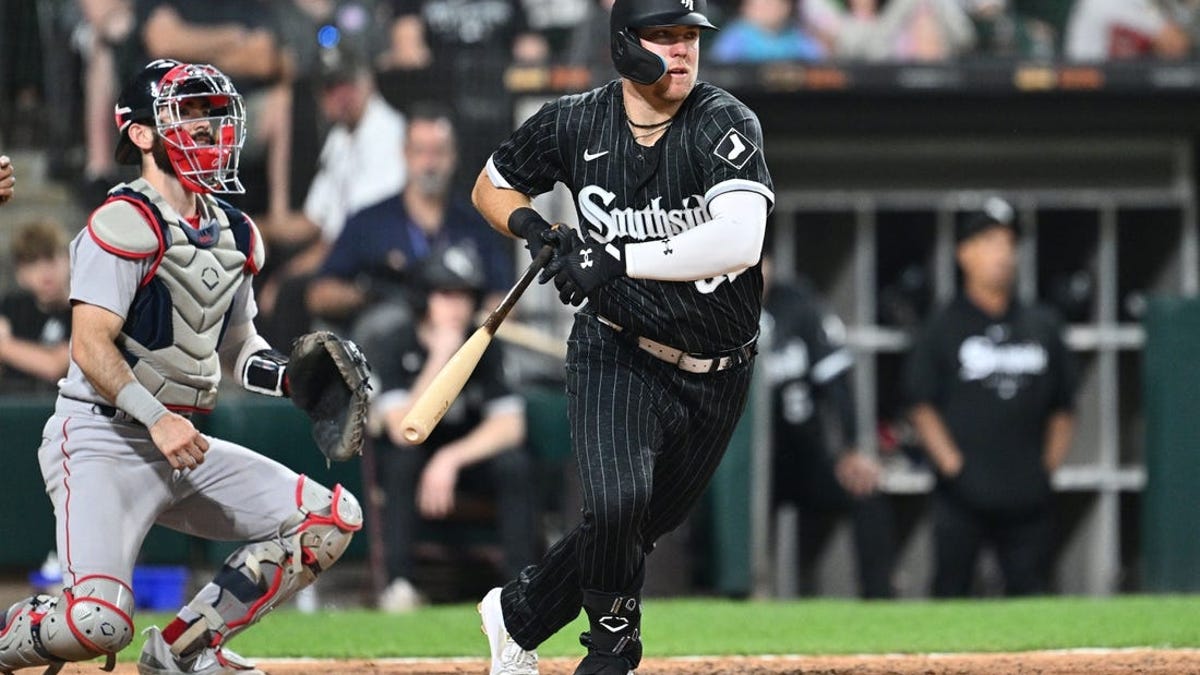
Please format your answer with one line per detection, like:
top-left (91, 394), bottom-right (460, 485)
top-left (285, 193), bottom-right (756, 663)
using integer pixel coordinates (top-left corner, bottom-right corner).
top-left (88, 179), bottom-right (263, 412)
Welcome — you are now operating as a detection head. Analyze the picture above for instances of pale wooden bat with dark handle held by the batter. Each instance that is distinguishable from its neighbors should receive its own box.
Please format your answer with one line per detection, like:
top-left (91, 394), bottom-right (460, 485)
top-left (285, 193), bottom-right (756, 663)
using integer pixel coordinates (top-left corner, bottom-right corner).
top-left (401, 245), bottom-right (554, 444)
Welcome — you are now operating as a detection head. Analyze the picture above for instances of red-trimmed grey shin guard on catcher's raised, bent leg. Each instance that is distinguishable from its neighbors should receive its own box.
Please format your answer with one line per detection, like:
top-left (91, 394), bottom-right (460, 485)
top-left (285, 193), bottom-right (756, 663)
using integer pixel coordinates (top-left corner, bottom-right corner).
top-left (172, 476), bottom-right (362, 655)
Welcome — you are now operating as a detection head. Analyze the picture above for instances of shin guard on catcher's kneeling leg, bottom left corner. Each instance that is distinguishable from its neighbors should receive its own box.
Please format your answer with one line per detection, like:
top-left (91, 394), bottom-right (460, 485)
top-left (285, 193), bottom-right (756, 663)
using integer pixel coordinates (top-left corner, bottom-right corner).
top-left (0, 575), bottom-right (133, 671)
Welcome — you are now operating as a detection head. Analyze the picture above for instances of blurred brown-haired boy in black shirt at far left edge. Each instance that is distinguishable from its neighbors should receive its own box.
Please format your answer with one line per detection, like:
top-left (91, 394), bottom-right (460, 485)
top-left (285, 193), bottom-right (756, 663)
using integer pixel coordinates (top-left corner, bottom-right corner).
top-left (0, 220), bottom-right (71, 394)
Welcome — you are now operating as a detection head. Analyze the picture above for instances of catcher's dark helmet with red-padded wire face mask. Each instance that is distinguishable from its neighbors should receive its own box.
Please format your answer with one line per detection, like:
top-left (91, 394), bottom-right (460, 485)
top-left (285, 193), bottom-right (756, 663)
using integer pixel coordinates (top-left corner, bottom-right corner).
top-left (114, 59), bottom-right (246, 192)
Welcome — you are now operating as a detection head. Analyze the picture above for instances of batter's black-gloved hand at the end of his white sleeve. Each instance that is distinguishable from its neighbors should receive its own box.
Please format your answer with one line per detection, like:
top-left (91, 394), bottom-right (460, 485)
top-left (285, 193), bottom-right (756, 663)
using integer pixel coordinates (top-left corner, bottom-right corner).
top-left (538, 227), bottom-right (625, 306)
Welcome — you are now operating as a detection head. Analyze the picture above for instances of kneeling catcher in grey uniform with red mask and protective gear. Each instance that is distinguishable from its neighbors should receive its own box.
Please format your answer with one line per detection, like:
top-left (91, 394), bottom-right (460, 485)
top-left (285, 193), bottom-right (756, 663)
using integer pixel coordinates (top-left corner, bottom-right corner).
top-left (0, 60), bottom-right (361, 675)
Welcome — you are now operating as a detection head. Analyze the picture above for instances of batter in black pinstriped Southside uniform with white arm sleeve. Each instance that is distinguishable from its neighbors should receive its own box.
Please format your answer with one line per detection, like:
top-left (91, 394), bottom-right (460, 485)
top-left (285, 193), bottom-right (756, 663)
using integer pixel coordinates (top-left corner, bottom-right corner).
top-left (474, 0), bottom-right (774, 675)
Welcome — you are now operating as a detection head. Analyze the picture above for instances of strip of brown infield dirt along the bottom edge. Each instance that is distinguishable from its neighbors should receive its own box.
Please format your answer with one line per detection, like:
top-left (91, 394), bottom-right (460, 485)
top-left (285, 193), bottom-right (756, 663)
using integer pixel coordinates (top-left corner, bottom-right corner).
top-left (54, 650), bottom-right (1200, 675)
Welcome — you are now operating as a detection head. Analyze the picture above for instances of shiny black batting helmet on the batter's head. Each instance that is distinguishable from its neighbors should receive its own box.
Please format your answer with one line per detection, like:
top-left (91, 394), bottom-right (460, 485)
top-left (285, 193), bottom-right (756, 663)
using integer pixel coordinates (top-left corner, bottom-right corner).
top-left (610, 0), bottom-right (718, 84)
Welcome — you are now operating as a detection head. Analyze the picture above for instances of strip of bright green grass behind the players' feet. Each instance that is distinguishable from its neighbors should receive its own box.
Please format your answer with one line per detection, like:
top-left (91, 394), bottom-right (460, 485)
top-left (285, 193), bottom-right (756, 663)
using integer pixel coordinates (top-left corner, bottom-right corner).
top-left (114, 596), bottom-right (1200, 659)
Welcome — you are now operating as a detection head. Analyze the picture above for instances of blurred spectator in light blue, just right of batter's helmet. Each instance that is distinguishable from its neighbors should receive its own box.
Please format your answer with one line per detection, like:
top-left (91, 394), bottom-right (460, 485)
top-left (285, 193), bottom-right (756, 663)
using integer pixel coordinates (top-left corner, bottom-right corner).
top-left (712, 0), bottom-right (824, 64)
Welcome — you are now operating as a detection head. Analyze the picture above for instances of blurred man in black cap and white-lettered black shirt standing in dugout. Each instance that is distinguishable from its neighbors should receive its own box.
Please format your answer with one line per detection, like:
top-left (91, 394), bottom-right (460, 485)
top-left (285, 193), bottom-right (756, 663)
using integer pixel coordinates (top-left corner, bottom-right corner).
top-left (905, 199), bottom-right (1075, 597)
